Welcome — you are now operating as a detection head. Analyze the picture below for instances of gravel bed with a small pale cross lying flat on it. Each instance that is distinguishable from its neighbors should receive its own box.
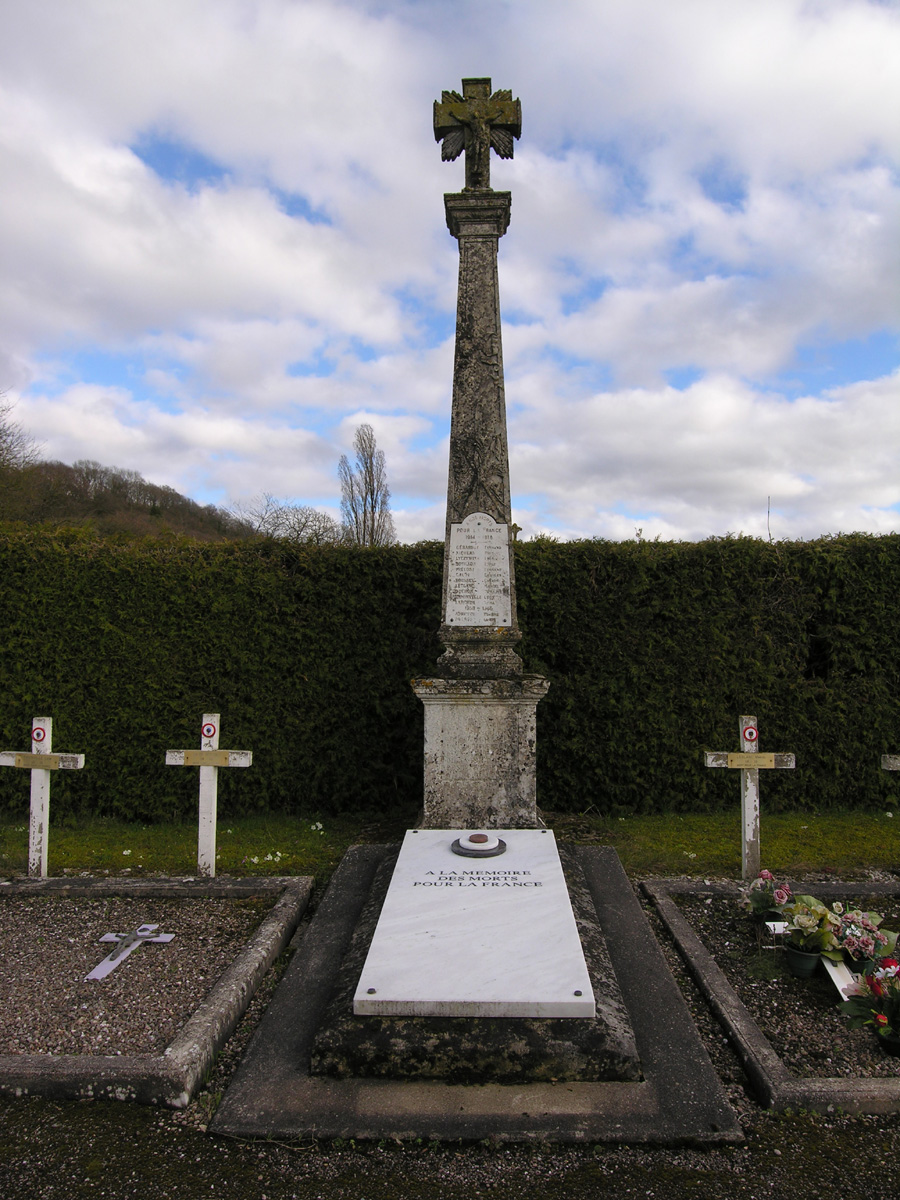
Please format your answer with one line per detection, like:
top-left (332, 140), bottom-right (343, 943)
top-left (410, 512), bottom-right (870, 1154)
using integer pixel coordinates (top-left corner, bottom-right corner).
top-left (0, 896), bottom-right (271, 1056)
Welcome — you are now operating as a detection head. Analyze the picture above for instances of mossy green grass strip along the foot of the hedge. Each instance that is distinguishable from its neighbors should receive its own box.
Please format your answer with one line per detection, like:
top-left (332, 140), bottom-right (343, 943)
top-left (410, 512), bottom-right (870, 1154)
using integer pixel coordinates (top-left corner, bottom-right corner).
top-left (0, 810), bottom-right (900, 884)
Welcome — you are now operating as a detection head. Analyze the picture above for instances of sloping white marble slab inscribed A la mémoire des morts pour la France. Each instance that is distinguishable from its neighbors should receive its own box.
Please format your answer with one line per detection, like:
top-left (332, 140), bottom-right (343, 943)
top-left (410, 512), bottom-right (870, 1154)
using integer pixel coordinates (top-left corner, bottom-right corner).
top-left (353, 829), bottom-right (595, 1018)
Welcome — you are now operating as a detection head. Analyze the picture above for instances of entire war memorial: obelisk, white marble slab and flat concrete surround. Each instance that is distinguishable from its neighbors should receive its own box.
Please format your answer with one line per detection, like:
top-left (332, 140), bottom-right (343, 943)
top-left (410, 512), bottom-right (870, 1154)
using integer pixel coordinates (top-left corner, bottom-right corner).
top-left (210, 79), bottom-right (739, 1145)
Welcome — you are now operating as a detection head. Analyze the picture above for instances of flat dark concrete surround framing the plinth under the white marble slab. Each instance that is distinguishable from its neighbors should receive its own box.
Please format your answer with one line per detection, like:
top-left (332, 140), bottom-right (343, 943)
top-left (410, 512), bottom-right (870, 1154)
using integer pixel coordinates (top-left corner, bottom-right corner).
top-left (209, 846), bottom-right (743, 1146)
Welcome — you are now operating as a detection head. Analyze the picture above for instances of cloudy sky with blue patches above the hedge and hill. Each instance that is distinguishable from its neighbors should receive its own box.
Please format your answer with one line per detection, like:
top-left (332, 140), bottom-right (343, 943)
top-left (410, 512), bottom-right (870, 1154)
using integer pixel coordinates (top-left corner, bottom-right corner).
top-left (0, 0), bottom-right (900, 541)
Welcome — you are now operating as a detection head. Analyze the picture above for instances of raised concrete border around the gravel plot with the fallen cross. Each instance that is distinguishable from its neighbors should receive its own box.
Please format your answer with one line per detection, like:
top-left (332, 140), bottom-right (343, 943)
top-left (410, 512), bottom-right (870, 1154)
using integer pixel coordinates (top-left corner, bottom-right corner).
top-left (0, 875), bottom-right (313, 1108)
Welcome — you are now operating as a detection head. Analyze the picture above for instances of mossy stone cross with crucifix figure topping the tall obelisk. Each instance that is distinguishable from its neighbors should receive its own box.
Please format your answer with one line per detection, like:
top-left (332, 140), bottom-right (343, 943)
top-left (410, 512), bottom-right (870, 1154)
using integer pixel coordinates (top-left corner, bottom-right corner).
top-left (434, 79), bottom-right (522, 192)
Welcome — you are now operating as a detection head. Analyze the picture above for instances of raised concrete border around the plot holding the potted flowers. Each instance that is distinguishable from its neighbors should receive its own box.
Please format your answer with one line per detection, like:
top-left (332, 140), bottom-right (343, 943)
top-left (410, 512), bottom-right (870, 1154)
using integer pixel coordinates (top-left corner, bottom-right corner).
top-left (641, 880), bottom-right (900, 1114)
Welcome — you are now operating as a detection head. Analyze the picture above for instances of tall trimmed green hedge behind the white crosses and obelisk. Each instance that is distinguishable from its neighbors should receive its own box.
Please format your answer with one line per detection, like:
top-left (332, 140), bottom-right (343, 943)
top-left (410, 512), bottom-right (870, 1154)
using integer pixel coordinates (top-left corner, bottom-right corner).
top-left (0, 532), bottom-right (900, 820)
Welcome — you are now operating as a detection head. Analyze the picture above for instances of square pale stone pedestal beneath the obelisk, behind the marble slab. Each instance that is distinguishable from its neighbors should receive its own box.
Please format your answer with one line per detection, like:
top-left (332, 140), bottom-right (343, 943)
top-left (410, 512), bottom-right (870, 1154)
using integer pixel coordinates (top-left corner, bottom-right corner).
top-left (413, 676), bottom-right (550, 829)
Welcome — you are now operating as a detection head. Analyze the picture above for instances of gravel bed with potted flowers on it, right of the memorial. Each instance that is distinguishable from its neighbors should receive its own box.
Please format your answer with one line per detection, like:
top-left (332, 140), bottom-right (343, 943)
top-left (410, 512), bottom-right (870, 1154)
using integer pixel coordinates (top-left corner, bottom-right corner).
top-left (676, 884), bottom-right (900, 1079)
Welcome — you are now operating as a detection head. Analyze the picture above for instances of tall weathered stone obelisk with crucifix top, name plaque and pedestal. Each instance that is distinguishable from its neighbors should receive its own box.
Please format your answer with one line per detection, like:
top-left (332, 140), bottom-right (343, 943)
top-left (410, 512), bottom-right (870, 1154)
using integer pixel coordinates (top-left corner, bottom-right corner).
top-left (413, 72), bottom-right (550, 829)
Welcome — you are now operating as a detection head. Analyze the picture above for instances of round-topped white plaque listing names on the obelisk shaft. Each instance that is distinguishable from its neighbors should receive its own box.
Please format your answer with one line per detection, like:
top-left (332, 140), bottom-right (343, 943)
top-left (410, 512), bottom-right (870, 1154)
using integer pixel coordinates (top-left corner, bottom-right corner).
top-left (445, 512), bottom-right (512, 628)
